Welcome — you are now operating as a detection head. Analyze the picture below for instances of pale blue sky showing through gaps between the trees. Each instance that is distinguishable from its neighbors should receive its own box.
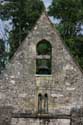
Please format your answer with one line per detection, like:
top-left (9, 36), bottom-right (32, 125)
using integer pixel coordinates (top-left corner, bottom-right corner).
top-left (0, 0), bottom-right (53, 39)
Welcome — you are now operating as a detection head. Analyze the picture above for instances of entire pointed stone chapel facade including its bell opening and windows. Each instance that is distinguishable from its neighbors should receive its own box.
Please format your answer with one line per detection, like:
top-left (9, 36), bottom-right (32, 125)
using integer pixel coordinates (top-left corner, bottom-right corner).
top-left (0, 13), bottom-right (83, 125)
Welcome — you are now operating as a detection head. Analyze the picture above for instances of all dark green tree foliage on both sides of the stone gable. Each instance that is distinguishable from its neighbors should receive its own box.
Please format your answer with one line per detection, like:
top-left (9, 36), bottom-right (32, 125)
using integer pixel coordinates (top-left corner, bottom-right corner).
top-left (0, 0), bottom-right (83, 71)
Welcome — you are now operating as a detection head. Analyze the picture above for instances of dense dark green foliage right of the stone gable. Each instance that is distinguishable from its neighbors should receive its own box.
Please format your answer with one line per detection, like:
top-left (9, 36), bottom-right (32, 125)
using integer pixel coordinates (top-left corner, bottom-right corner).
top-left (48, 0), bottom-right (83, 68)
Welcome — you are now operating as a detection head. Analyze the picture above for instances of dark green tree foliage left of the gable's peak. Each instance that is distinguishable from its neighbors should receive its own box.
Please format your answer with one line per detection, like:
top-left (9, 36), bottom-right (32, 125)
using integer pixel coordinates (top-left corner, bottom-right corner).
top-left (0, 0), bottom-right (44, 72)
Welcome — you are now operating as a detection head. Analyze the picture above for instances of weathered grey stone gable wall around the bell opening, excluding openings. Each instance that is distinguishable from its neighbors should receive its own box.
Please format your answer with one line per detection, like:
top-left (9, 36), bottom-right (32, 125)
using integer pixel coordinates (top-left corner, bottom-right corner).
top-left (0, 14), bottom-right (83, 113)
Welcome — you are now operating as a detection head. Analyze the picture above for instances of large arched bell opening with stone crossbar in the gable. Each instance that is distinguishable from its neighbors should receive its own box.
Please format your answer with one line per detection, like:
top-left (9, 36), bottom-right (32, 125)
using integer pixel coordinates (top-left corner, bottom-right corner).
top-left (36, 40), bottom-right (52, 75)
